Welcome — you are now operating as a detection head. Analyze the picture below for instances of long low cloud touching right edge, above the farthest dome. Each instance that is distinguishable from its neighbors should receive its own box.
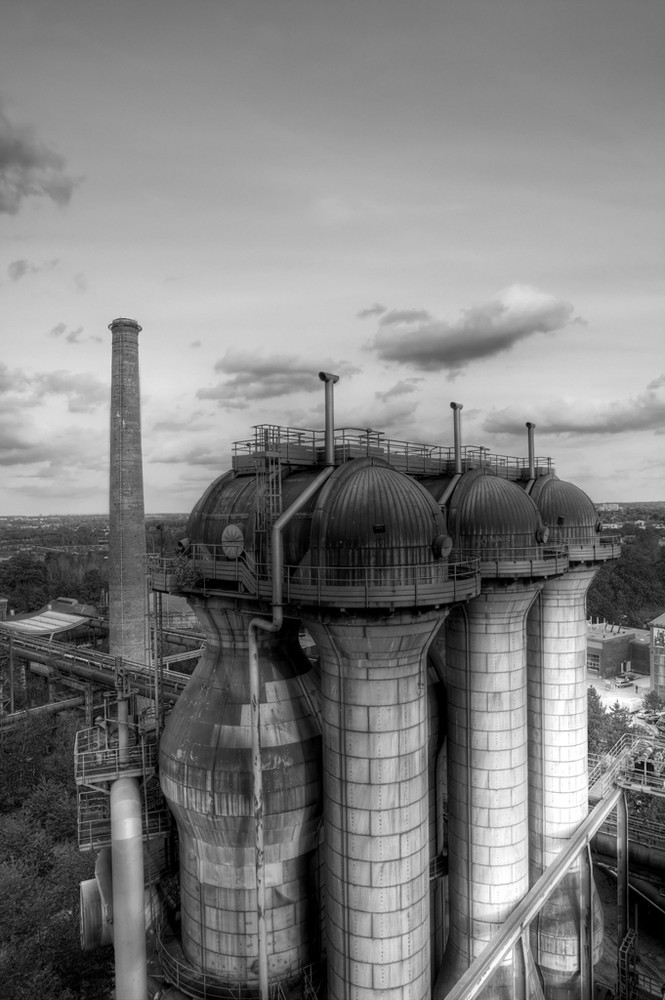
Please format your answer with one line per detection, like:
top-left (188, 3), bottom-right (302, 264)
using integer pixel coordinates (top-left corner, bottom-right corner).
top-left (483, 374), bottom-right (665, 435)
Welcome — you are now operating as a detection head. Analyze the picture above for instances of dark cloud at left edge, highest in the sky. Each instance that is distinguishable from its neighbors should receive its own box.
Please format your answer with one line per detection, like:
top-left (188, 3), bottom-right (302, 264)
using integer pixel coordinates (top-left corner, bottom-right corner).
top-left (0, 108), bottom-right (78, 215)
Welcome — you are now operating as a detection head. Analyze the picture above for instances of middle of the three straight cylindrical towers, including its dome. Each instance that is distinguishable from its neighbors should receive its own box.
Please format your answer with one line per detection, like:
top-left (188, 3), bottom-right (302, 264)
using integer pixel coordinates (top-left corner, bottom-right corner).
top-left (434, 469), bottom-right (565, 1000)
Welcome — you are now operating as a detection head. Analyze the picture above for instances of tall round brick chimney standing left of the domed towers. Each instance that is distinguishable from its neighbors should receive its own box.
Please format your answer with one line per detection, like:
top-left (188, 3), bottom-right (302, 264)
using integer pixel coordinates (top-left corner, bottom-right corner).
top-left (109, 319), bottom-right (147, 662)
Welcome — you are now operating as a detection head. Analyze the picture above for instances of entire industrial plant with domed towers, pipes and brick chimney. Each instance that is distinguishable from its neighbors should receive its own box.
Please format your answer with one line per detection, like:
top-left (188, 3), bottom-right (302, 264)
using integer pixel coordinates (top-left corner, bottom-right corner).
top-left (70, 319), bottom-right (636, 1000)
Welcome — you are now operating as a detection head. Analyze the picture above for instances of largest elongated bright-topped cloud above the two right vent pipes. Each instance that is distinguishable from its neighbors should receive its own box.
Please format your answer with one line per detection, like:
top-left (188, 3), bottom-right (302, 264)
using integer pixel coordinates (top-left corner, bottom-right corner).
top-left (370, 285), bottom-right (583, 375)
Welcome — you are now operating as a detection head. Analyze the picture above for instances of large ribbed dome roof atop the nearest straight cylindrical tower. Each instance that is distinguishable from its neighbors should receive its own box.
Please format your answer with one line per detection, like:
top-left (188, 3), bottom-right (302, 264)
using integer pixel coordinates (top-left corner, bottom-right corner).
top-left (310, 457), bottom-right (445, 551)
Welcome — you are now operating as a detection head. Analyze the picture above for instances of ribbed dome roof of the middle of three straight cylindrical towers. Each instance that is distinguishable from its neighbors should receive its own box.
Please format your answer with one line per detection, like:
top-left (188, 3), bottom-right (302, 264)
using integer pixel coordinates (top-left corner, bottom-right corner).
top-left (448, 469), bottom-right (541, 545)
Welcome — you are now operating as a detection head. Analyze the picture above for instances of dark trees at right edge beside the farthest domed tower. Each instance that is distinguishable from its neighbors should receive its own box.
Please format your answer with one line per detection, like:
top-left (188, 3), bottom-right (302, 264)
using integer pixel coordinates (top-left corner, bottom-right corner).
top-left (587, 524), bottom-right (665, 628)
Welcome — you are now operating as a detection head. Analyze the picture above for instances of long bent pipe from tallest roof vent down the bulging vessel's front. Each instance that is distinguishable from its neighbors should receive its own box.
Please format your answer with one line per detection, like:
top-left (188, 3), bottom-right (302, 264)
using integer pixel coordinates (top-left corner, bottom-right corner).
top-left (248, 372), bottom-right (339, 1000)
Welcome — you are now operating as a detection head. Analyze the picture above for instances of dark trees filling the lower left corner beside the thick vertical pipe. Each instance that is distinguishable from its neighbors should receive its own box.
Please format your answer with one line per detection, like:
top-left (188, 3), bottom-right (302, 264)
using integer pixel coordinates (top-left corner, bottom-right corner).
top-left (0, 713), bottom-right (113, 1000)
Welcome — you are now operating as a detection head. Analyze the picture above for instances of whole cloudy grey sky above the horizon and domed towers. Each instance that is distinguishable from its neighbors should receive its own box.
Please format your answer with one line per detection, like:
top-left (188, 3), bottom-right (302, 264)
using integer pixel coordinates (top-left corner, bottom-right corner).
top-left (0, 0), bottom-right (665, 515)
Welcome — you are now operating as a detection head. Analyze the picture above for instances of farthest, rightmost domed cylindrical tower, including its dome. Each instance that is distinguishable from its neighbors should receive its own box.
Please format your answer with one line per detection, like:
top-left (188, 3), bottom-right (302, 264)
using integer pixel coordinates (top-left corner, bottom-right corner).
top-left (527, 475), bottom-right (612, 1000)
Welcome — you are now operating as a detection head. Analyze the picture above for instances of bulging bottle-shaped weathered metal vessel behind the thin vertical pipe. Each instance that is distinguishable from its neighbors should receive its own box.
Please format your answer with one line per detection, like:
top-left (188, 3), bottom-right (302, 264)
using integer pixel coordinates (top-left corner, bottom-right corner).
top-left (160, 598), bottom-right (322, 986)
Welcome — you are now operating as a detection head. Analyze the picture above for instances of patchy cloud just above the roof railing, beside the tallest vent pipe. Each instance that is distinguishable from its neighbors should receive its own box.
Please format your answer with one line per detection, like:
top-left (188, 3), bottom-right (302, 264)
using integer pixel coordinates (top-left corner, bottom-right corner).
top-left (196, 351), bottom-right (359, 410)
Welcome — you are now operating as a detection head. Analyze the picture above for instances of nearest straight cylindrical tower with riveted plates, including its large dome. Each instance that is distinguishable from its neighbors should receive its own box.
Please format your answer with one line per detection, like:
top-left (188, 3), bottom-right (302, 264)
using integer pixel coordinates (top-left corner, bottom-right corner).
top-left (303, 458), bottom-right (466, 1000)
